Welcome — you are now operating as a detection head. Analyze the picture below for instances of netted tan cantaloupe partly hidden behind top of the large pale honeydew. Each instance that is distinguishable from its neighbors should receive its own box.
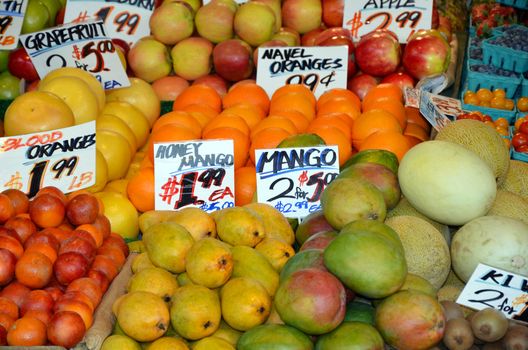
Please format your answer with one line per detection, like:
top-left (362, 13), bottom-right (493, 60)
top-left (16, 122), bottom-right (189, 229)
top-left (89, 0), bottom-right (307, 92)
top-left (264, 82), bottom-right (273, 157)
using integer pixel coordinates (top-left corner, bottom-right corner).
top-left (435, 119), bottom-right (510, 184)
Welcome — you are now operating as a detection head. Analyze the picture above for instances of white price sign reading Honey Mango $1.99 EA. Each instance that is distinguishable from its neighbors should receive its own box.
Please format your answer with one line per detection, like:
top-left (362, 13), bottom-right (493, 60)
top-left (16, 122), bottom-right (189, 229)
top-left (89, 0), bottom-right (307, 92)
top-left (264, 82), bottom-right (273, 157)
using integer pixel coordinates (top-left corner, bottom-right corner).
top-left (154, 140), bottom-right (235, 212)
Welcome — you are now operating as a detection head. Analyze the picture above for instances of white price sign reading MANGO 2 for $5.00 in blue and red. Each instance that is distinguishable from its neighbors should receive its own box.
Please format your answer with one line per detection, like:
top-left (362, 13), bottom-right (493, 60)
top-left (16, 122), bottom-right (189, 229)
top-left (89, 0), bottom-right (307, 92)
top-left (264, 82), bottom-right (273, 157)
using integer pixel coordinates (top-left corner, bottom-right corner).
top-left (255, 146), bottom-right (339, 218)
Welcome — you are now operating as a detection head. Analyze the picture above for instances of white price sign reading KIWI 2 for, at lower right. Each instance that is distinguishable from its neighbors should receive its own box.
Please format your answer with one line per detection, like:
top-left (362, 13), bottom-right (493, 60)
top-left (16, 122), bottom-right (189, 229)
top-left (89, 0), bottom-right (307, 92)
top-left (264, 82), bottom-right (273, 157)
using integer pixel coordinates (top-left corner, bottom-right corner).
top-left (456, 264), bottom-right (528, 324)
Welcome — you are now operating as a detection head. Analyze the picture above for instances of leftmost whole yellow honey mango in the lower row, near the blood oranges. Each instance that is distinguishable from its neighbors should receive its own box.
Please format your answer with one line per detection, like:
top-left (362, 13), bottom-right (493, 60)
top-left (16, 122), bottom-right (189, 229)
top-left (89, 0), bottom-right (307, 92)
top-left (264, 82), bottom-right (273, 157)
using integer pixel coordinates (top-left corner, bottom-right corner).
top-left (117, 292), bottom-right (170, 342)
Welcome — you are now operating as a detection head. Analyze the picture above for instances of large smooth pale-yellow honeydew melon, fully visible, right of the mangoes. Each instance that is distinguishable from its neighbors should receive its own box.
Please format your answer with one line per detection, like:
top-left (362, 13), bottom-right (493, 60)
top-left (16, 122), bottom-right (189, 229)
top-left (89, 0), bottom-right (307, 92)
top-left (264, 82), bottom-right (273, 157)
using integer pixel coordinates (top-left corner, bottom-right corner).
top-left (398, 140), bottom-right (497, 226)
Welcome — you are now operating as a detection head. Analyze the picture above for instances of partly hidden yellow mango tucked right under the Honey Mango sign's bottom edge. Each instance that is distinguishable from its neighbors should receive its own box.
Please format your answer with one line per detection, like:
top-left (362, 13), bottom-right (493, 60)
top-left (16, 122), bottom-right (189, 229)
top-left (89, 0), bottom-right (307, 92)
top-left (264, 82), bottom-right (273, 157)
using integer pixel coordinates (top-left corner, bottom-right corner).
top-left (168, 207), bottom-right (216, 241)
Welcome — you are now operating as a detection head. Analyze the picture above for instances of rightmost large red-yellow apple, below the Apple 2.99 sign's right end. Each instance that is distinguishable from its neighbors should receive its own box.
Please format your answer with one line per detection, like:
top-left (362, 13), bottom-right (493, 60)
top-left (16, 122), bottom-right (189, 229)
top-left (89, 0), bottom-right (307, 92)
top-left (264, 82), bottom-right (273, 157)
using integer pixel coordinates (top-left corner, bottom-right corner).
top-left (402, 29), bottom-right (451, 80)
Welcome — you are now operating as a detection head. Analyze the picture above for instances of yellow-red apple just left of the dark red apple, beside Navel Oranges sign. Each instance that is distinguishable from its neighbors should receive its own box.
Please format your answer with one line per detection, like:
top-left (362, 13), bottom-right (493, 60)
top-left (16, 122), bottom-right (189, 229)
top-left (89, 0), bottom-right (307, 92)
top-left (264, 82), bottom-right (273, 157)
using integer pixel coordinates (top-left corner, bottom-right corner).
top-left (171, 37), bottom-right (214, 80)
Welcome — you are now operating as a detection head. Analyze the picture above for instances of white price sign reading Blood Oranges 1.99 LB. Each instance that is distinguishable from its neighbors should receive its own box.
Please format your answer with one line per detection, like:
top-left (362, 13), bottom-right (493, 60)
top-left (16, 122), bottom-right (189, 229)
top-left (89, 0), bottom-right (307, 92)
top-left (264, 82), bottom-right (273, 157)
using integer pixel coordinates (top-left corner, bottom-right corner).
top-left (0, 121), bottom-right (95, 197)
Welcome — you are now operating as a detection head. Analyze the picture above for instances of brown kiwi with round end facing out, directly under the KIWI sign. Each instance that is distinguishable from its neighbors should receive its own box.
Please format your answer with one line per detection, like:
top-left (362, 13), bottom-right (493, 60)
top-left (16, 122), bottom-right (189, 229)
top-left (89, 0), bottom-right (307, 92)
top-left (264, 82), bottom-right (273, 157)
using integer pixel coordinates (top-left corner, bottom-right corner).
top-left (470, 307), bottom-right (509, 343)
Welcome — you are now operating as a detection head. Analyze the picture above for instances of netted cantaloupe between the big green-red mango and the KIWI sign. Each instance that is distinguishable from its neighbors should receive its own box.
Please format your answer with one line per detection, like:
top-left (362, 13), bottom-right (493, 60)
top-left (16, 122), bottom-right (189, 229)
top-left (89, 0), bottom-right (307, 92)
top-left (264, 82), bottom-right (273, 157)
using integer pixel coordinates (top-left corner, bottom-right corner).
top-left (385, 215), bottom-right (451, 289)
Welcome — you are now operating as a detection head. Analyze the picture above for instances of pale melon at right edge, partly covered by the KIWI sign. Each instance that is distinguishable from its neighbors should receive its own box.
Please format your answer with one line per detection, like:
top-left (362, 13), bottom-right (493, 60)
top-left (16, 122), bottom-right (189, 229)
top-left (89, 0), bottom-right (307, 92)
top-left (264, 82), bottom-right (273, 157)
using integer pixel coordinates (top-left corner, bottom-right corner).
top-left (451, 216), bottom-right (528, 282)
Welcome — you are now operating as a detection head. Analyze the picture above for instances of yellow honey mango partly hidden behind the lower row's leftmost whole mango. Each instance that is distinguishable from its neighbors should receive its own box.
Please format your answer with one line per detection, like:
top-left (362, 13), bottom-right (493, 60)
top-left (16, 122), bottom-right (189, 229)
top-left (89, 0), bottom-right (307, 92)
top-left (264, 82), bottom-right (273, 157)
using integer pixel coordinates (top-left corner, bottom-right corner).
top-left (127, 267), bottom-right (178, 303)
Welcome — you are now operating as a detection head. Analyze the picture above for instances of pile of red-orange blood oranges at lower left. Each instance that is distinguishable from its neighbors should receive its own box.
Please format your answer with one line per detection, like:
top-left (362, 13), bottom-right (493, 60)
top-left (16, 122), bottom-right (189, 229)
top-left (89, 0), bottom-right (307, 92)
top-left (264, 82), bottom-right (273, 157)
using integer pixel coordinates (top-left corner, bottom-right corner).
top-left (0, 187), bottom-right (128, 348)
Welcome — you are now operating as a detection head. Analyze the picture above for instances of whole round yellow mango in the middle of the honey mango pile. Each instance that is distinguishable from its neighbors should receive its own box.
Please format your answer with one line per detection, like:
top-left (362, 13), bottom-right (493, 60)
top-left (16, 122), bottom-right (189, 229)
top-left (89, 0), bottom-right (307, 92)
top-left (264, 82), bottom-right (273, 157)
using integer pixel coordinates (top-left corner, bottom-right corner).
top-left (185, 237), bottom-right (233, 288)
